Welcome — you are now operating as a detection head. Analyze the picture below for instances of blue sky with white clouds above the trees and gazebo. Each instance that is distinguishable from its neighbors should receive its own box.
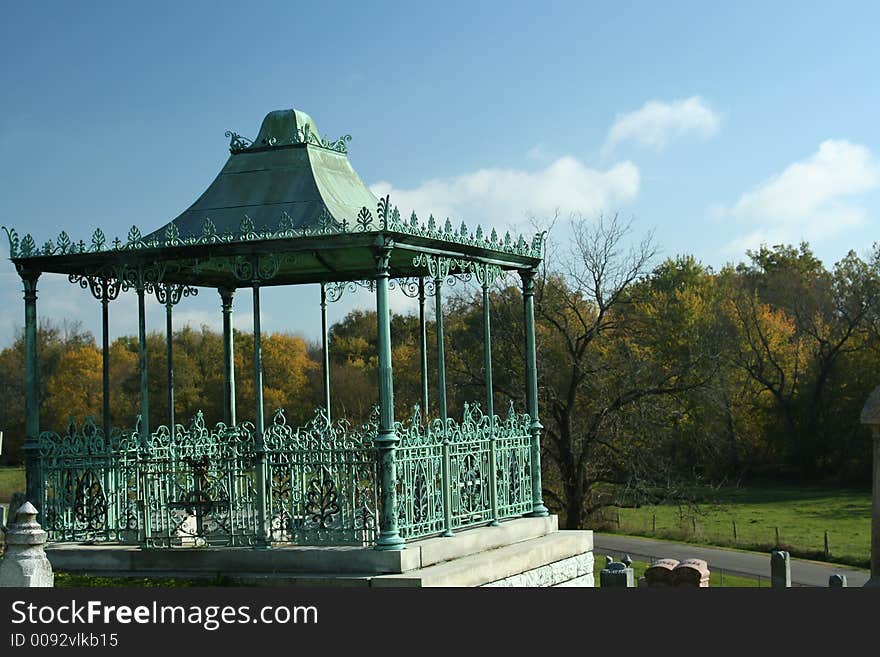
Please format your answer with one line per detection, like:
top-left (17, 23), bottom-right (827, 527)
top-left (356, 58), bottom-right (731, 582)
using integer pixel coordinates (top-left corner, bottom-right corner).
top-left (0, 1), bottom-right (880, 346)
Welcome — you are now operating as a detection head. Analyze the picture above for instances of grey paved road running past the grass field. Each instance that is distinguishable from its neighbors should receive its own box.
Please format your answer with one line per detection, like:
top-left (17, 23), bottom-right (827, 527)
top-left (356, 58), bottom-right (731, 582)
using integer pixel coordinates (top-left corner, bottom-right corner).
top-left (593, 533), bottom-right (869, 587)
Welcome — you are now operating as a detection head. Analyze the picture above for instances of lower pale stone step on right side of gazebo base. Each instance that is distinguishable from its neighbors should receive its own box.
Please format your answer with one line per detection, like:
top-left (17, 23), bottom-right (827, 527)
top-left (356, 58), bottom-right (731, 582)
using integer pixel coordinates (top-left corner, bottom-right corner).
top-left (370, 530), bottom-right (593, 587)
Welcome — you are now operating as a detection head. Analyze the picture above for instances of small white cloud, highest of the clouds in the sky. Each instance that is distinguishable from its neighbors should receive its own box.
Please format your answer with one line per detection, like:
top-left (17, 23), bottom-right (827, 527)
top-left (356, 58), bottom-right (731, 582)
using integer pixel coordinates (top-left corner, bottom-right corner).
top-left (602, 96), bottom-right (721, 155)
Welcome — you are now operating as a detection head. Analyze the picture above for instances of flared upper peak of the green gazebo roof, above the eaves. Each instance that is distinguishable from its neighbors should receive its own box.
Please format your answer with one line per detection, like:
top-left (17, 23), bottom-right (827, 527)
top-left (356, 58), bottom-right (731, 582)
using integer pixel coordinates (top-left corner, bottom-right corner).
top-left (145, 109), bottom-right (377, 241)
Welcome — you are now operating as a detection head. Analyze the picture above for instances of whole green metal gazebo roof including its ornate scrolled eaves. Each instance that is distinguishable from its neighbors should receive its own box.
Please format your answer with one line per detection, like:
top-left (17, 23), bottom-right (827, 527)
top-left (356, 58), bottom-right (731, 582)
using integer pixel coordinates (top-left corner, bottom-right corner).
top-left (3, 105), bottom-right (544, 287)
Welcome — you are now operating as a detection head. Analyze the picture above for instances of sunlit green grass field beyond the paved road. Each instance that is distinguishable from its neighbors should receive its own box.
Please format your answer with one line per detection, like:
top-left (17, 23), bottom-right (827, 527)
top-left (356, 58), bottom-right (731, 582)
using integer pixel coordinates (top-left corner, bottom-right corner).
top-left (592, 485), bottom-right (871, 568)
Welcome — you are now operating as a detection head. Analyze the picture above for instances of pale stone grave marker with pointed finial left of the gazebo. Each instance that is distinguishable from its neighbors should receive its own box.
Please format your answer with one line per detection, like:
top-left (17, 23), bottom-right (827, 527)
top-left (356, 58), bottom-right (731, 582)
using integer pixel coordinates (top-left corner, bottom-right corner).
top-left (0, 502), bottom-right (55, 587)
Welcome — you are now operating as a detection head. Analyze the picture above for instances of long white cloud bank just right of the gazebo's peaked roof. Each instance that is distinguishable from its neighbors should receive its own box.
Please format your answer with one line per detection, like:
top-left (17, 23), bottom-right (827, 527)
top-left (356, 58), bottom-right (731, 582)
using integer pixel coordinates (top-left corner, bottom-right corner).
top-left (370, 156), bottom-right (640, 229)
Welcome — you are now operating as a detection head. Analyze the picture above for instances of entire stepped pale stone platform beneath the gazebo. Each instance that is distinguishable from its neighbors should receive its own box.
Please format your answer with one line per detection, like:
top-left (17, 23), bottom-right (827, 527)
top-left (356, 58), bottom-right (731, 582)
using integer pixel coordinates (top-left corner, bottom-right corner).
top-left (46, 516), bottom-right (593, 587)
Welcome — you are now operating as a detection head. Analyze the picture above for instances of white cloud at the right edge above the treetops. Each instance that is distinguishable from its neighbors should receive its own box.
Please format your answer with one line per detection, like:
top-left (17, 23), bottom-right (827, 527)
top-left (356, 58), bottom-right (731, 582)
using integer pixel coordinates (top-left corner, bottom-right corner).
top-left (718, 139), bottom-right (880, 253)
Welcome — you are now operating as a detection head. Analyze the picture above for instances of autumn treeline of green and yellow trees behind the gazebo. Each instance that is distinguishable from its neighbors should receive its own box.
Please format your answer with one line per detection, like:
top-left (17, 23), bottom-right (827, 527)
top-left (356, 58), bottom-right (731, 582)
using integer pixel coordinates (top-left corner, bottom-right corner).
top-left (0, 220), bottom-right (880, 527)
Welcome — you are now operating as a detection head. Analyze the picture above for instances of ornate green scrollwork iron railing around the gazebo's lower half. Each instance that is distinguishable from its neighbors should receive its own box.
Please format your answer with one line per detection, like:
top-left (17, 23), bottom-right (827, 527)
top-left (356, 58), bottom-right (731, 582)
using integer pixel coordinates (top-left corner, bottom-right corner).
top-left (38, 404), bottom-right (532, 547)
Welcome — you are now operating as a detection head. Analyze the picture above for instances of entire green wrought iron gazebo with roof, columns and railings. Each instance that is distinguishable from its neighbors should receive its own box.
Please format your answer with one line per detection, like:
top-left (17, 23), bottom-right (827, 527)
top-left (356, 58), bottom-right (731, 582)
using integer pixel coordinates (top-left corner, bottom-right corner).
top-left (5, 110), bottom-right (547, 550)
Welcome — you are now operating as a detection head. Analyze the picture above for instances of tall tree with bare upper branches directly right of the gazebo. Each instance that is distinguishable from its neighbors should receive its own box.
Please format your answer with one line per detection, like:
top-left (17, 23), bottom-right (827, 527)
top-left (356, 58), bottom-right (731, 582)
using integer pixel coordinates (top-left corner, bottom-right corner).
top-left (536, 215), bottom-right (705, 528)
